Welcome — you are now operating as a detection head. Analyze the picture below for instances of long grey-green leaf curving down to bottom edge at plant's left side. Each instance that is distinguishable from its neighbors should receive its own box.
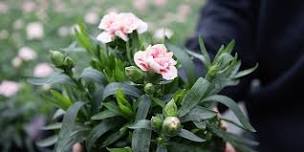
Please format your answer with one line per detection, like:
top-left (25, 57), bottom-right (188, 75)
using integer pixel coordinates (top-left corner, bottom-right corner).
top-left (55, 102), bottom-right (87, 152)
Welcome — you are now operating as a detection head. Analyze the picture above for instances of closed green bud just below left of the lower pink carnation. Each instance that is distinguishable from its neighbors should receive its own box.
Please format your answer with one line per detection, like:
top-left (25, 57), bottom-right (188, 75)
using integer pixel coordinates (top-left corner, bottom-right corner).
top-left (125, 66), bottom-right (144, 83)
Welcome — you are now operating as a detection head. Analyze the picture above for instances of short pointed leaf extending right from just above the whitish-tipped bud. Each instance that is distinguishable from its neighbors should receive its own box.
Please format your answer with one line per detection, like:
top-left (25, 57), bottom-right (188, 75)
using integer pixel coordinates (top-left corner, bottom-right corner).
top-left (181, 106), bottom-right (217, 122)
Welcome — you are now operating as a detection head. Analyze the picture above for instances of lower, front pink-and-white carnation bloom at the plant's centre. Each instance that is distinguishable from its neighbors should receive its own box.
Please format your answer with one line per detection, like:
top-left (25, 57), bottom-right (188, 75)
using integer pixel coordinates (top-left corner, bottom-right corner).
top-left (134, 44), bottom-right (177, 80)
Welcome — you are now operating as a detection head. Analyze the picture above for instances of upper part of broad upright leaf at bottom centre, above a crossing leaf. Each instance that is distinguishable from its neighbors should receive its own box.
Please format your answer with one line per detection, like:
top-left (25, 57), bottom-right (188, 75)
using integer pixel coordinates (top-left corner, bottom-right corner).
top-left (135, 95), bottom-right (151, 120)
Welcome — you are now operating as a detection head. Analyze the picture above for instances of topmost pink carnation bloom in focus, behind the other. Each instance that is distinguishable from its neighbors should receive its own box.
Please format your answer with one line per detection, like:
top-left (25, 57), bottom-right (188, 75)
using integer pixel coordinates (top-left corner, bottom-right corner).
top-left (97, 12), bottom-right (148, 43)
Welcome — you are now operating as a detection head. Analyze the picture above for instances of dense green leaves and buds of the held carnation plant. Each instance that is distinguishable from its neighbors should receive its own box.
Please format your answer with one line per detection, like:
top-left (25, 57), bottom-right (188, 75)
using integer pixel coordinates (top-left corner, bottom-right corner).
top-left (30, 15), bottom-right (255, 152)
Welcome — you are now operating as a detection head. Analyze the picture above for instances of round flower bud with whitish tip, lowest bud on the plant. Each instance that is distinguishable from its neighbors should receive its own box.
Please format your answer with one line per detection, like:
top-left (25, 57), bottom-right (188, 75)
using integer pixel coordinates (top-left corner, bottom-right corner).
top-left (162, 117), bottom-right (182, 136)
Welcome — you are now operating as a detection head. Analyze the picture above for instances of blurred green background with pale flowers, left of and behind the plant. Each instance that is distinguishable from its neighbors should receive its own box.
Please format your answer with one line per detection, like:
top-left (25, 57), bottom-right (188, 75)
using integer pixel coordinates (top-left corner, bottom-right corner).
top-left (0, 0), bottom-right (204, 151)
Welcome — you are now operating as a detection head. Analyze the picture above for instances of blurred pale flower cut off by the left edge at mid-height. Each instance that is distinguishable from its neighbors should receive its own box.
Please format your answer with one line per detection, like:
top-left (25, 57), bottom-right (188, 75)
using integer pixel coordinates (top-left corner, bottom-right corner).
top-left (0, 80), bottom-right (20, 97)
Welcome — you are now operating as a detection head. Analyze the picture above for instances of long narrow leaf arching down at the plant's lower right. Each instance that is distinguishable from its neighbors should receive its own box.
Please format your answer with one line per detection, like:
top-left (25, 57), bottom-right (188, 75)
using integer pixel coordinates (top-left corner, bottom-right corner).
top-left (202, 95), bottom-right (255, 132)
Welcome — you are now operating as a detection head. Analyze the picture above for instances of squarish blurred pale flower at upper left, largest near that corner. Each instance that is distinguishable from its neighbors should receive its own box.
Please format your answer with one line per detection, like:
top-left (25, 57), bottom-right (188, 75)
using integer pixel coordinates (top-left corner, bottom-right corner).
top-left (26, 22), bottom-right (44, 40)
